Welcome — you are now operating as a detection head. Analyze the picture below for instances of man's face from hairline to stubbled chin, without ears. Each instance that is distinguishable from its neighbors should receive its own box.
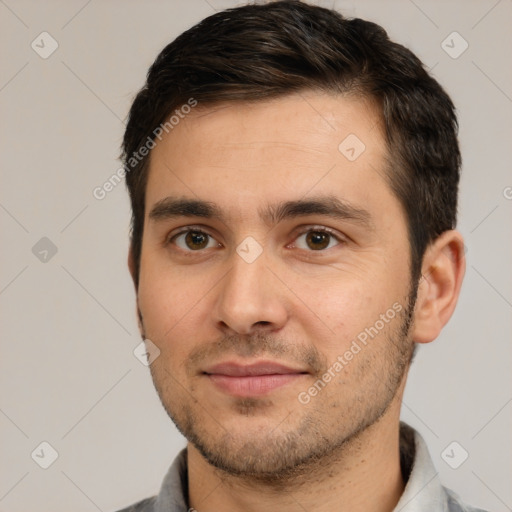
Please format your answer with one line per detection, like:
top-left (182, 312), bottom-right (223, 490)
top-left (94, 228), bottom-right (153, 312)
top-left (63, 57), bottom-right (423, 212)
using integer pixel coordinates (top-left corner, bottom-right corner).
top-left (138, 92), bottom-right (413, 477)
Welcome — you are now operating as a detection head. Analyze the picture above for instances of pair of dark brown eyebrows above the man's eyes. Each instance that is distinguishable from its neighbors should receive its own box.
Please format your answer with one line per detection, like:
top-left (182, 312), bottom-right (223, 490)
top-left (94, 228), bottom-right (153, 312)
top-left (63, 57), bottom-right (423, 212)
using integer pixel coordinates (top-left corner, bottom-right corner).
top-left (149, 195), bottom-right (373, 229)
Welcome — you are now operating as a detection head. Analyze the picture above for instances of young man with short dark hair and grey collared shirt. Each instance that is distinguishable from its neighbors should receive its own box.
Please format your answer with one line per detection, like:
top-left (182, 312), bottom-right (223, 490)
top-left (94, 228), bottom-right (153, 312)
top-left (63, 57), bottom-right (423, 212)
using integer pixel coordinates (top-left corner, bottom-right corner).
top-left (117, 1), bottom-right (488, 512)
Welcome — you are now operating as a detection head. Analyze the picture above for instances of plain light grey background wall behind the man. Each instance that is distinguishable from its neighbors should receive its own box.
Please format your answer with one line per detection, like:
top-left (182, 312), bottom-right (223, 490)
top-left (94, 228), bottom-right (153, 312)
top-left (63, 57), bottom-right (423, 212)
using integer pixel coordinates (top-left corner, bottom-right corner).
top-left (0, 0), bottom-right (512, 512)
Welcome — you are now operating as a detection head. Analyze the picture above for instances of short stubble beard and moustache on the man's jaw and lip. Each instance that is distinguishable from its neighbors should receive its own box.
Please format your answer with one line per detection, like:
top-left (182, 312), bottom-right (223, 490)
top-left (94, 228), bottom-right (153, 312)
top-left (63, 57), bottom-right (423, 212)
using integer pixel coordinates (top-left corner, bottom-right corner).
top-left (145, 288), bottom-right (416, 488)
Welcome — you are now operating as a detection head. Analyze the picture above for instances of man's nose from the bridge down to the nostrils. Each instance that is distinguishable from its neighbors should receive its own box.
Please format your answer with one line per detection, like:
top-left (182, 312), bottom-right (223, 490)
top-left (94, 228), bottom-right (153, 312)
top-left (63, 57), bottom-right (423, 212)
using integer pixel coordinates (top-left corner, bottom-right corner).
top-left (213, 248), bottom-right (289, 335)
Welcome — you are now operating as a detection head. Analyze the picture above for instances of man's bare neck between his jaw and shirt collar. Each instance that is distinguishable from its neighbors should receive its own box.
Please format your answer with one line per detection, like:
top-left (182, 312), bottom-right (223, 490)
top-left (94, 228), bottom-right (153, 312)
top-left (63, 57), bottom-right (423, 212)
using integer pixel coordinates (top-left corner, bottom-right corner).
top-left (187, 404), bottom-right (404, 512)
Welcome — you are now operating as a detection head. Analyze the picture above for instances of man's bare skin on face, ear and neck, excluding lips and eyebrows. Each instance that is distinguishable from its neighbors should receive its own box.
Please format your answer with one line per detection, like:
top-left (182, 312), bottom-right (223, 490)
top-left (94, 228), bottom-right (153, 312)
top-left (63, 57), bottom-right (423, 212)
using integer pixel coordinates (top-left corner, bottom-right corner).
top-left (129, 91), bottom-right (464, 512)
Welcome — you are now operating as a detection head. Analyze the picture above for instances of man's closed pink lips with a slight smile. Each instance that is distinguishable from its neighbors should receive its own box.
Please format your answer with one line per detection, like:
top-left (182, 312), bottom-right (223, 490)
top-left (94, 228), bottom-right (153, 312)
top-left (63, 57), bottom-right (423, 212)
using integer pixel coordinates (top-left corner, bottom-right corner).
top-left (203, 361), bottom-right (309, 397)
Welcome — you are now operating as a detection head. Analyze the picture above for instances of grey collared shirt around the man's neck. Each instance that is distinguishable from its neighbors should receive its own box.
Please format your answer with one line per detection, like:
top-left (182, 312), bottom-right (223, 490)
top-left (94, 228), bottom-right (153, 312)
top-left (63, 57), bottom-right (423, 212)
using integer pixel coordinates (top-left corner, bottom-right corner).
top-left (118, 422), bottom-right (485, 512)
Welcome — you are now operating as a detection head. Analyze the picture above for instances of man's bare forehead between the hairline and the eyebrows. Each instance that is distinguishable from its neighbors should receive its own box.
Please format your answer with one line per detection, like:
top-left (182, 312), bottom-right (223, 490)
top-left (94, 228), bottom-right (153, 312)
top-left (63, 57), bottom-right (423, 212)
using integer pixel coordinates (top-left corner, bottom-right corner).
top-left (146, 91), bottom-right (390, 220)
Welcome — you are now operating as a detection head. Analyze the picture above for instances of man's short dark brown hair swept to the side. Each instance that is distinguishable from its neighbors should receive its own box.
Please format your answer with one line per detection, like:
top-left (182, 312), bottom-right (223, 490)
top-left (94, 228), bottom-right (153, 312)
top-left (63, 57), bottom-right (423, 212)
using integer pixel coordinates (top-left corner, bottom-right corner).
top-left (122, 0), bottom-right (461, 280)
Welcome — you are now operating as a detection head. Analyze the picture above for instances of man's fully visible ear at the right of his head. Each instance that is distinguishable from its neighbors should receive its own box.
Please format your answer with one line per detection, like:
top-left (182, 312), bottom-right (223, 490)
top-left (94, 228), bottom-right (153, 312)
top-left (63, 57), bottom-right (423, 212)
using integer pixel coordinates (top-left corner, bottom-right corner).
top-left (412, 230), bottom-right (466, 343)
